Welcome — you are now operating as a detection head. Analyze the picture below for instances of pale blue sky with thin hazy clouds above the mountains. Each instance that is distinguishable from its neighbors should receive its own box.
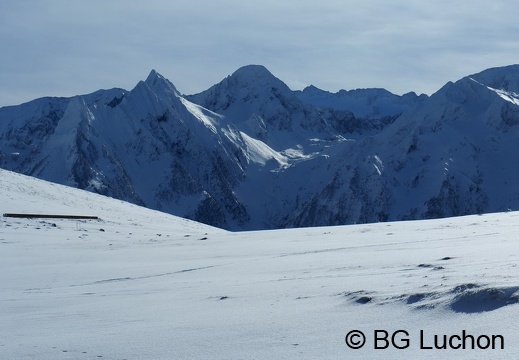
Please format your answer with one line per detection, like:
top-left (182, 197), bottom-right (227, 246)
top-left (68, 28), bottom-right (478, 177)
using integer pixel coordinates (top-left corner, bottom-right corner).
top-left (0, 0), bottom-right (519, 106)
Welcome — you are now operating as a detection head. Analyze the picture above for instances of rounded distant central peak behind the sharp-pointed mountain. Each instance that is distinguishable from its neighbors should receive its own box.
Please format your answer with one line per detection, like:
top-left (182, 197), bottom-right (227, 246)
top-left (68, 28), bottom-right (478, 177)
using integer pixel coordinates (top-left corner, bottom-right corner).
top-left (187, 65), bottom-right (392, 151)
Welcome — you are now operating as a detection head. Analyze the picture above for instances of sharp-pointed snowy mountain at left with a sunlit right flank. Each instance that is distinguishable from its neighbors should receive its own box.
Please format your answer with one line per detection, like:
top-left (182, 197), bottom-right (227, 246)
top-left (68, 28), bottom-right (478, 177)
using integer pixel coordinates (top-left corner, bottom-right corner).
top-left (0, 71), bottom-right (276, 227)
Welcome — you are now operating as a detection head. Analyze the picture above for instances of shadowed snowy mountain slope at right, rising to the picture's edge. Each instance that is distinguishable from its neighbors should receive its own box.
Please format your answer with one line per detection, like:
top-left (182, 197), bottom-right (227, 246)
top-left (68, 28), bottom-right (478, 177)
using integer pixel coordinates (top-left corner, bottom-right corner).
top-left (286, 66), bottom-right (519, 226)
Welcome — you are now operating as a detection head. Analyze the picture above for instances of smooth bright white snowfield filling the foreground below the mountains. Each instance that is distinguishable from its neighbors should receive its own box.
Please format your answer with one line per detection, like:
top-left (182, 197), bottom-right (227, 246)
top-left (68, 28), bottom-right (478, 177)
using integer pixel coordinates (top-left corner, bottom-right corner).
top-left (0, 170), bottom-right (519, 359)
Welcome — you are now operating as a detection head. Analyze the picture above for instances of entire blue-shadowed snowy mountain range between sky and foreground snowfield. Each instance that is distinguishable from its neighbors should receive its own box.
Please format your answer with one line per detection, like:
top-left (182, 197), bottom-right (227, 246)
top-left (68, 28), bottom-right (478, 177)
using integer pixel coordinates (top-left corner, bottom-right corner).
top-left (0, 65), bottom-right (519, 230)
